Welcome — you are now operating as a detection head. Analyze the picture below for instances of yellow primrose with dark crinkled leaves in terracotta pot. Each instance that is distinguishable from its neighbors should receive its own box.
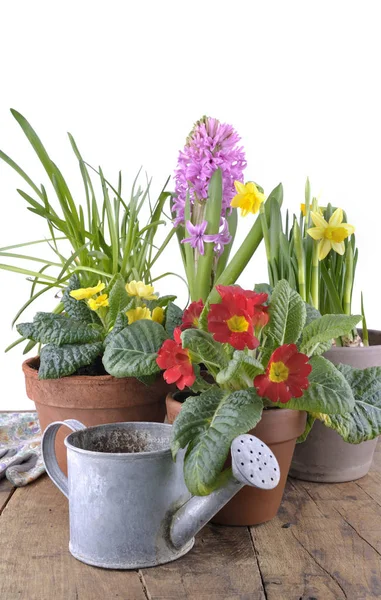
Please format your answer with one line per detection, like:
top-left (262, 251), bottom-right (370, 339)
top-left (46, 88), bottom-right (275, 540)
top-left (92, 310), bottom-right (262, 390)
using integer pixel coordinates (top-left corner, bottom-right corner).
top-left (17, 274), bottom-right (182, 474)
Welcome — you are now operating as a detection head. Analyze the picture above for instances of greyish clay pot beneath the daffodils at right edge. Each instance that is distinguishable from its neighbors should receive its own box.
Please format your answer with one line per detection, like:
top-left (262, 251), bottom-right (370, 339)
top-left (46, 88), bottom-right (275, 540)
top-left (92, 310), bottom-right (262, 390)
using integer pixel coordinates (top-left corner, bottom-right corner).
top-left (290, 330), bottom-right (381, 483)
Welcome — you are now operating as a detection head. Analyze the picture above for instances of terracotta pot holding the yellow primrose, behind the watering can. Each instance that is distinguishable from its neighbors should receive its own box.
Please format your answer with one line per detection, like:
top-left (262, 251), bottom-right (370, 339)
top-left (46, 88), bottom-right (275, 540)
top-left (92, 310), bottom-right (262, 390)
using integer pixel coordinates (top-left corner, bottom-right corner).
top-left (22, 357), bottom-right (170, 473)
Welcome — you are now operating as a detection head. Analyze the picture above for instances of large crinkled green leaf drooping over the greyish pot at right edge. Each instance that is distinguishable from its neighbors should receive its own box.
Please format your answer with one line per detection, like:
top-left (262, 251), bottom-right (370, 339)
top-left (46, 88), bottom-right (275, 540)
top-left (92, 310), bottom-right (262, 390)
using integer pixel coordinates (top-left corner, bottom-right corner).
top-left (314, 365), bottom-right (381, 444)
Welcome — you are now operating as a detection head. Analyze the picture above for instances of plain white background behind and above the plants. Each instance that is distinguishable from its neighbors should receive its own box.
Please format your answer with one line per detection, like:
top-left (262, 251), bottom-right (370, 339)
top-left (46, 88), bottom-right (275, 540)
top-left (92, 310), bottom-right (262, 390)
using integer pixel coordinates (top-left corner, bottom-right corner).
top-left (0, 0), bottom-right (381, 410)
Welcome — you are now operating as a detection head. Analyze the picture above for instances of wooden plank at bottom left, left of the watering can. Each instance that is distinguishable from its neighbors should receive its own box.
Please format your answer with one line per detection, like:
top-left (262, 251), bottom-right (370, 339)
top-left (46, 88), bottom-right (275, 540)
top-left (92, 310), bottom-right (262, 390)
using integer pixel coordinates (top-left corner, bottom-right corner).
top-left (0, 476), bottom-right (147, 600)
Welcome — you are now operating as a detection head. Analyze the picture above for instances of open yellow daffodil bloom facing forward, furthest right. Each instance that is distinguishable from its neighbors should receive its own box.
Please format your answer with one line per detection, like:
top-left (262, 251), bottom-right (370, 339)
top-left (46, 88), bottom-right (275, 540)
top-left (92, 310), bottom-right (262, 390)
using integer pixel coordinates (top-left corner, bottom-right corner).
top-left (307, 208), bottom-right (355, 260)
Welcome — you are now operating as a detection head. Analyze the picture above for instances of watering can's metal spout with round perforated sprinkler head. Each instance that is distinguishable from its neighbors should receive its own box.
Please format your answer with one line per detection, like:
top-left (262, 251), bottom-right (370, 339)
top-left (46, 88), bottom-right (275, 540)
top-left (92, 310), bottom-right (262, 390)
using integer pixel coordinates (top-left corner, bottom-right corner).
top-left (170, 434), bottom-right (280, 548)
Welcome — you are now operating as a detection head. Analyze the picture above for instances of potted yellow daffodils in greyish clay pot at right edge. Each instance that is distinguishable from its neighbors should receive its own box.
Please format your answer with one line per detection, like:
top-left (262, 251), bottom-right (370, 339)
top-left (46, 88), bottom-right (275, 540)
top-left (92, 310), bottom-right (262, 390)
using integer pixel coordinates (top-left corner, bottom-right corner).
top-left (262, 180), bottom-right (381, 482)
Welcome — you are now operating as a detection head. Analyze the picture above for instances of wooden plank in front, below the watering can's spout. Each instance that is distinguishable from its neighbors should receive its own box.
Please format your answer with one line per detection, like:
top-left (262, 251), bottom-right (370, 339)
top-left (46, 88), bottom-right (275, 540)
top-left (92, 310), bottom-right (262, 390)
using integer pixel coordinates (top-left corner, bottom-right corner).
top-left (141, 525), bottom-right (264, 600)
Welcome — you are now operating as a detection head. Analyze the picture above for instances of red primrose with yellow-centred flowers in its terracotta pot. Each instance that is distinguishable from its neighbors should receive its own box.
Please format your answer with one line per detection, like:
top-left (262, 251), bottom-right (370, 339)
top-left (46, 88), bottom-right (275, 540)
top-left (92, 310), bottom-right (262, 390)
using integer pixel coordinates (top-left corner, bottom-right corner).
top-left (104, 280), bottom-right (360, 525)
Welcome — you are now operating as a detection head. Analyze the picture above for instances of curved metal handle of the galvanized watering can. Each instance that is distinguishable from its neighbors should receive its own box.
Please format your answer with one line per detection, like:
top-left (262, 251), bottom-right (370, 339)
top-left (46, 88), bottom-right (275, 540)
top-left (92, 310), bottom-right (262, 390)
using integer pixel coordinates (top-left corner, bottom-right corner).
top-left (41, 419), bottom-right (86, 498)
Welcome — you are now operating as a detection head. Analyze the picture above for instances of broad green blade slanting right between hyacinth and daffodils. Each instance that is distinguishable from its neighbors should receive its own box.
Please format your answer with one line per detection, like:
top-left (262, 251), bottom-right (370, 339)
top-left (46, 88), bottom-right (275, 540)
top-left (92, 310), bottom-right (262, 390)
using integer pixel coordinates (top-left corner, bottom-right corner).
top-left (207, 184), bottom-right (283, 303)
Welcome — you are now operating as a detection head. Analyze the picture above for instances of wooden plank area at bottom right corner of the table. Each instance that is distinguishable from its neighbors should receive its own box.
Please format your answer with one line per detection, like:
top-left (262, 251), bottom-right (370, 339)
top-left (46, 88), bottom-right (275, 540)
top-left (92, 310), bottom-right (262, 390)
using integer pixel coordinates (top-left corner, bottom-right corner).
top-left (251, 480), bottom-right (381, 600)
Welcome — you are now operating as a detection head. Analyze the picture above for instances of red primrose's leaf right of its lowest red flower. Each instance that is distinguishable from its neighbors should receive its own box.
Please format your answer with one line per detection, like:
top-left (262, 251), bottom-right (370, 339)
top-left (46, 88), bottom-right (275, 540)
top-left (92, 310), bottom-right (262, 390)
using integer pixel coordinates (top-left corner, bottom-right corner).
top-left (277, 356), bottom-right (355, 414)
